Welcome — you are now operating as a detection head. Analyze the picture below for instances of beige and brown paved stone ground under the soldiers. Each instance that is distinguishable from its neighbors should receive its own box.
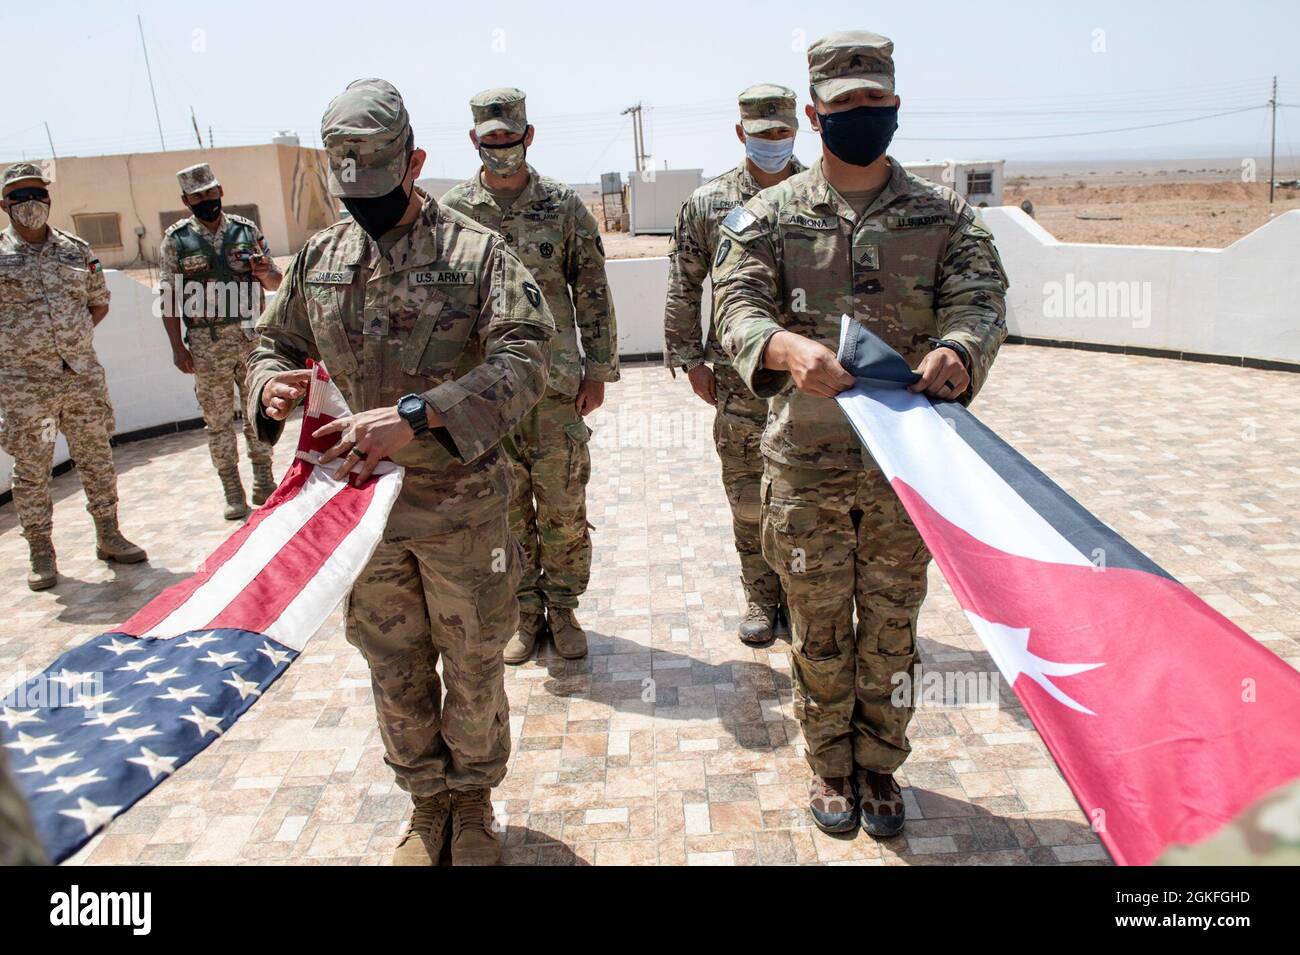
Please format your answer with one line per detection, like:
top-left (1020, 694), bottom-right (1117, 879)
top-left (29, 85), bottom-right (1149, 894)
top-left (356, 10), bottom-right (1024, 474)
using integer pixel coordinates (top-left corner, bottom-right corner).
top-left (0, 347), bottom-right (1300, 864)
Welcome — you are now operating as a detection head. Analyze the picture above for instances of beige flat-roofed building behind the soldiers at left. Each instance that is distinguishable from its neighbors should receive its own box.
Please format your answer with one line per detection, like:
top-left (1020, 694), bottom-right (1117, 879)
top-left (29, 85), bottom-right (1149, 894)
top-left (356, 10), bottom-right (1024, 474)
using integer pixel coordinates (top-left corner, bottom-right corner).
top-left (0, 143), bottom-right (338, 269)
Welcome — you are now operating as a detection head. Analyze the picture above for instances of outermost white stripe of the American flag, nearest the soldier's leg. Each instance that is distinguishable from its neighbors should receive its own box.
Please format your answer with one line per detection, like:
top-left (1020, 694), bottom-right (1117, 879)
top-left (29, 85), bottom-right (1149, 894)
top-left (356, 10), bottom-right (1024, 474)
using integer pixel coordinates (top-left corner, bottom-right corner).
top-left (264, 468), bottom-right (403, 650)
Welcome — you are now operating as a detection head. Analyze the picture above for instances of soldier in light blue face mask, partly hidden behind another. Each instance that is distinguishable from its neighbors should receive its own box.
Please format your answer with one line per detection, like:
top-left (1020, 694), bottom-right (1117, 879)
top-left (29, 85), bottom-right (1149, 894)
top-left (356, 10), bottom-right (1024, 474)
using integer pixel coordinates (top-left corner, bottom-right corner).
top-left (663, 83), bottom-right (803, 646)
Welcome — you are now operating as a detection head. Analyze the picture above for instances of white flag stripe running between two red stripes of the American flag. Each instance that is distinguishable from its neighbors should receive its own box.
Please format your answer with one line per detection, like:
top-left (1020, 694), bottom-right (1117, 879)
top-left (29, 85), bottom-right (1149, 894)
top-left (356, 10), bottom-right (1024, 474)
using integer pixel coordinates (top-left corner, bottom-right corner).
top-left (140, 468), bottom-right (347, 638)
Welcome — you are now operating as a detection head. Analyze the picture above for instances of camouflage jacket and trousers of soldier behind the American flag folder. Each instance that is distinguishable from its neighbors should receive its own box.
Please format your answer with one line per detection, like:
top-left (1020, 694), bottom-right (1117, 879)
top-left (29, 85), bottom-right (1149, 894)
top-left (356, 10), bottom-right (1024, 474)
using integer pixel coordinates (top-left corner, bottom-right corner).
top-left (441, 166), bottom-right (619, 613)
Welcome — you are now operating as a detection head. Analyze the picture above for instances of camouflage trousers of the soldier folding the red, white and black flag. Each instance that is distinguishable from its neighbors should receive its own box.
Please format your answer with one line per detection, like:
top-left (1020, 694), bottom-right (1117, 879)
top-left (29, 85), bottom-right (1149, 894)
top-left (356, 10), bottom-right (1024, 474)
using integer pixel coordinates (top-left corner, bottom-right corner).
top-left (763, 459), bottom-right (930, 776)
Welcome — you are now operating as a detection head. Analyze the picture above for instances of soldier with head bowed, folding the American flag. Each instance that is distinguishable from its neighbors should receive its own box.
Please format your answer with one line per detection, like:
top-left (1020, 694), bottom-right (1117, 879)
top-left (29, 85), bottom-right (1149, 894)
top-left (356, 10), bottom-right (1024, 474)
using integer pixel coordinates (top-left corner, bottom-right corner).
top-left (248, 79), bottom-right (555, 865)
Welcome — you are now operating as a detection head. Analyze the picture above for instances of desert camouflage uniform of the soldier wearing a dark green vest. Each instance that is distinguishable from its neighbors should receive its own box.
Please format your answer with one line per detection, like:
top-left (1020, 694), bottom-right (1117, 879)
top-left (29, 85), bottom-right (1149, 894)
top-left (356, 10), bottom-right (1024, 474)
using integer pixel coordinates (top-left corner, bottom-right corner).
top-left (159, 213), bottom-right (280, 473)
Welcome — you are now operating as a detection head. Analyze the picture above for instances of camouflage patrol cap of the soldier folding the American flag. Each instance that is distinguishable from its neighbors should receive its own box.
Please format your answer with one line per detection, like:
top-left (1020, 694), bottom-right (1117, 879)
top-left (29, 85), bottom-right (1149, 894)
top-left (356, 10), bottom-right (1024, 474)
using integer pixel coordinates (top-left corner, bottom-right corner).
top-left (321, 78), bottom-right (411, 199)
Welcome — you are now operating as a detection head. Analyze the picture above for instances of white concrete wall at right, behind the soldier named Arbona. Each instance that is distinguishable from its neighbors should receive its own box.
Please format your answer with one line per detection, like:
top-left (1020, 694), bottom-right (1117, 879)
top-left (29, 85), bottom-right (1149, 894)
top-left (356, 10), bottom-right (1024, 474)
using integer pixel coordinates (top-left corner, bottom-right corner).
top-left (982, 205), bottom-right (1300, 361)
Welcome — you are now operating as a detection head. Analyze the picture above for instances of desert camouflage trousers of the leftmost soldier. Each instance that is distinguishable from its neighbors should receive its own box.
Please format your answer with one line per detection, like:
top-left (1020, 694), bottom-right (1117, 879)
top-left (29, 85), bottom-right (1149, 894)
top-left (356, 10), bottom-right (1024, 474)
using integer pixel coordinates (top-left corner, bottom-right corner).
top-left (0, 368), bottom-right (117, 539)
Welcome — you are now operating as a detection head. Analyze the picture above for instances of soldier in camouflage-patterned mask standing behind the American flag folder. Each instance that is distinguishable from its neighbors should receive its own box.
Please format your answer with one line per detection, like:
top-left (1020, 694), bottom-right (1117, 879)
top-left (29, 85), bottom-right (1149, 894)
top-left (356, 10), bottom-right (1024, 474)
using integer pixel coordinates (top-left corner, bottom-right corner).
top-left (442, 88), bottom-right (619, 664)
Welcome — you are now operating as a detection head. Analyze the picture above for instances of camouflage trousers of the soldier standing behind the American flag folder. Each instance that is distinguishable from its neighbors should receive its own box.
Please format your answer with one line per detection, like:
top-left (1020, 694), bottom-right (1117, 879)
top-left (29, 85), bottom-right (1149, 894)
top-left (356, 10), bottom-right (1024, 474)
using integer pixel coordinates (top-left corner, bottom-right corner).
top-left (501, 388), bottom-right (592, 613)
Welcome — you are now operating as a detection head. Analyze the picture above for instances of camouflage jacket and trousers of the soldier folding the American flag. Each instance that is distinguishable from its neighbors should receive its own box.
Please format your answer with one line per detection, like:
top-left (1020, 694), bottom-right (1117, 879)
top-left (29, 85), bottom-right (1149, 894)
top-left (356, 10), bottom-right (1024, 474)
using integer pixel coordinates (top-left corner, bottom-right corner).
top-left (247, 194), bottom-right (554, 796)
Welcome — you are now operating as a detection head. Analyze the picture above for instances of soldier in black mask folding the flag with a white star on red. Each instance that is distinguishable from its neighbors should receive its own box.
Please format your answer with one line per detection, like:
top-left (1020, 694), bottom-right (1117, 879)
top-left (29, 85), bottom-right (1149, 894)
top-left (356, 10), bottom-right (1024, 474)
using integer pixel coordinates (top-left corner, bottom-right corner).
top-left (712, 32), bottom-right (1006, 835)
